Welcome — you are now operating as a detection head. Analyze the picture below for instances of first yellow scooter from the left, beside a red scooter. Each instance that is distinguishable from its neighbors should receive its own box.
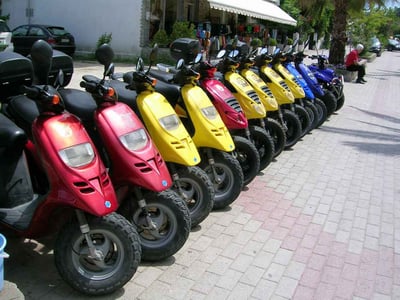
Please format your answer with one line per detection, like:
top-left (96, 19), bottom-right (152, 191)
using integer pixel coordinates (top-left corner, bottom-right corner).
top-left (105, 48), bottom-right (215, 227)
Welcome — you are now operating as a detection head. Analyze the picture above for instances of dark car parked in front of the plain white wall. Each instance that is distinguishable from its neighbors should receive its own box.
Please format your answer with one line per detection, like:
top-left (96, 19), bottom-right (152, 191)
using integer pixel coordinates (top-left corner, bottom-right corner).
top-left (12, 24), bottom-right (75, 56)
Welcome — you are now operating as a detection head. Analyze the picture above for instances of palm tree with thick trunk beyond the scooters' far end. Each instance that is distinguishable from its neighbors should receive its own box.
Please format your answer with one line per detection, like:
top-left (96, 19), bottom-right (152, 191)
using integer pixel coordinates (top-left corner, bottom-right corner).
top-left (298, 0), bottom-right (386, 64)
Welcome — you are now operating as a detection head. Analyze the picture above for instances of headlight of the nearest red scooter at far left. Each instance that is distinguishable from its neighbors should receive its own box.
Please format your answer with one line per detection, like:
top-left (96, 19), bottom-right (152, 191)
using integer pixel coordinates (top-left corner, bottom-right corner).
top-left (58, 143), bottom-right (94, 168)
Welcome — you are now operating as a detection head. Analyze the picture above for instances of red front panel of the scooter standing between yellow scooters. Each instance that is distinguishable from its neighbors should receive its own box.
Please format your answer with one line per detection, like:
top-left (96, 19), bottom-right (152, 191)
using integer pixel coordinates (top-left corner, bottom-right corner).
top-left (200, 78), bottom-right (248, 129)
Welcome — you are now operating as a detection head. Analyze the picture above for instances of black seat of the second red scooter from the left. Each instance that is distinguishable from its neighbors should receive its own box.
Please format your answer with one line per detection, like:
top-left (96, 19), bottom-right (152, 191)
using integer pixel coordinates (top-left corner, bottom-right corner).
top-left (58, 88), bottom-right (97, 124)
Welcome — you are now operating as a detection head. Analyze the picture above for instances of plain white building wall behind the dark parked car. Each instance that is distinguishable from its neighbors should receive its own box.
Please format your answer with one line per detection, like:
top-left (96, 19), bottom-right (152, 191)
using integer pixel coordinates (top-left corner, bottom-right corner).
top-left (2, 0), bottom-right (142, 55)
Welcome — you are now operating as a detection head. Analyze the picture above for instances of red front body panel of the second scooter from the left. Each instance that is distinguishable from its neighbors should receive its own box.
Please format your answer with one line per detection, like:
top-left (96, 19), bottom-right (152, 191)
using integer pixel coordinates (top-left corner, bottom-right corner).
top-left (95, 102), bottom-right (172, 192)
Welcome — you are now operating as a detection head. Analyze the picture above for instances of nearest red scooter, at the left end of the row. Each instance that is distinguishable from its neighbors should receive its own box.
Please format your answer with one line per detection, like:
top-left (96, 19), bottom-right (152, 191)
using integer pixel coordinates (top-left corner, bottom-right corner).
top-left (0, 49), bottom-right (141, 295)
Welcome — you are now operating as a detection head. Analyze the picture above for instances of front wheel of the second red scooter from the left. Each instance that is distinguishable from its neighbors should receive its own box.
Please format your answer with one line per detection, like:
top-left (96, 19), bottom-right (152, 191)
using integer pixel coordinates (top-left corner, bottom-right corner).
top-left (124, 190), bottom-right (191, 261)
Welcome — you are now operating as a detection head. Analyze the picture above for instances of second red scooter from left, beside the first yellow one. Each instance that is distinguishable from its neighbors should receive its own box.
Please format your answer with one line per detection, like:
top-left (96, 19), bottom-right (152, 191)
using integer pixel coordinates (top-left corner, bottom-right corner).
top-left (42, 41), bottom-right (191, 261)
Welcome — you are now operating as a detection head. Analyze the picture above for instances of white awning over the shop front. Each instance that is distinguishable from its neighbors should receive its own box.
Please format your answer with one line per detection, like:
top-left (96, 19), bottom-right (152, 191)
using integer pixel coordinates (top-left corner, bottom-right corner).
top-left (208, 0), bottom-right (297, 26)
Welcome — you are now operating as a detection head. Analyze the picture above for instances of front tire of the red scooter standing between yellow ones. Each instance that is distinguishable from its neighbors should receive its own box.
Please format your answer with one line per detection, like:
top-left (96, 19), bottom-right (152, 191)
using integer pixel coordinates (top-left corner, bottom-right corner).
top-left (232, 135), bottom-right (260, 185)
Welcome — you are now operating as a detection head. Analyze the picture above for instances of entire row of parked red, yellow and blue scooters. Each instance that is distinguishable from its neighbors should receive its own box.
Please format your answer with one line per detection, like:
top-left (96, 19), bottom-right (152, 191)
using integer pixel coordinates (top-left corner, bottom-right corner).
top-left (0, 39), bottom-right (344, 295)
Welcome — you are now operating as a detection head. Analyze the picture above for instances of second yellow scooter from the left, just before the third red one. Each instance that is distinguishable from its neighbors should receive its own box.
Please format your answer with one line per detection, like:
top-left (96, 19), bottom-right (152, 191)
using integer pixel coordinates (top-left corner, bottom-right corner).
top-left (150, 53), bottom-right (243, 209)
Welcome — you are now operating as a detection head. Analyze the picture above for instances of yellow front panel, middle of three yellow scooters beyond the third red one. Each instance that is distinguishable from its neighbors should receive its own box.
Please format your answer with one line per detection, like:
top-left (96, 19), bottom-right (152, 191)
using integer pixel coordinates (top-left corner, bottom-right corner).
top-left (240, 69), bottom-right (279, 112)
